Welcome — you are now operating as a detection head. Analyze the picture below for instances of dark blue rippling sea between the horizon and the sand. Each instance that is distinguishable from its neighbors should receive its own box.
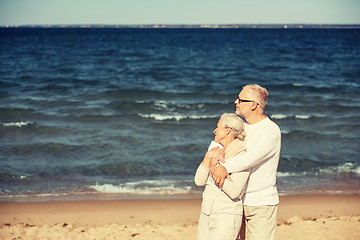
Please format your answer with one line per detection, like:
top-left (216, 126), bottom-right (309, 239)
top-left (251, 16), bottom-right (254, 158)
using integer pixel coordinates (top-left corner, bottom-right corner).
top-left (0, 27), bottom-right (360, 201)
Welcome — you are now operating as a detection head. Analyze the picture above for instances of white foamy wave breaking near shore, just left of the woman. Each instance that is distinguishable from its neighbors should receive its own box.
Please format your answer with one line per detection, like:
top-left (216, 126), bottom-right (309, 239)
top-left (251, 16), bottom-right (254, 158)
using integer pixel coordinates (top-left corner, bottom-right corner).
top-left (90, 180), bottom-right (192, 195)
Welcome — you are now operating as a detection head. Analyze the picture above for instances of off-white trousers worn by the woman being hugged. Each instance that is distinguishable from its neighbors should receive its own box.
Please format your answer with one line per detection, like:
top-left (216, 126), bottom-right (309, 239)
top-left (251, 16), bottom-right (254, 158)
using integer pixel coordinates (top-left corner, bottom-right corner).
top-left (197, 213), bottom-right (242, 240)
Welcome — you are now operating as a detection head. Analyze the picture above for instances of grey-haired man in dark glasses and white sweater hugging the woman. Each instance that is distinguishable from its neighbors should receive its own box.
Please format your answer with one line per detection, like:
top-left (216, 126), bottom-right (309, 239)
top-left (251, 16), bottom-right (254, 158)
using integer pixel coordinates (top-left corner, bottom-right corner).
top-left (213, 85), bottom-right (281, 240)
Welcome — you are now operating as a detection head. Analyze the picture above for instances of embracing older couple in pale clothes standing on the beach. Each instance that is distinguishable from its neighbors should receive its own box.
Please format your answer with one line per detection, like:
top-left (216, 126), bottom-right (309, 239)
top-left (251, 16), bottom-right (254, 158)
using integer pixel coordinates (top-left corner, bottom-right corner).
top-left (195, 85), bottom-right (281, 240)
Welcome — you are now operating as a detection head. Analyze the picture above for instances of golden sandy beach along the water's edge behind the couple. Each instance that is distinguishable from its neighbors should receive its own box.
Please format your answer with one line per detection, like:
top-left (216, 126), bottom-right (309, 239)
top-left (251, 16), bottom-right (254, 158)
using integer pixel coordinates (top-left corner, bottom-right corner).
top-left (0, 195), bottom-right (360, 240)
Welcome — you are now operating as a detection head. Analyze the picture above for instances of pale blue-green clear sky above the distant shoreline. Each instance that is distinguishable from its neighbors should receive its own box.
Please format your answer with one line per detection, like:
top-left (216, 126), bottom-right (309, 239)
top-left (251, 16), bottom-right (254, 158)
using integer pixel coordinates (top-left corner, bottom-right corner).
top-left (0, 0), bottom-right (360, 26)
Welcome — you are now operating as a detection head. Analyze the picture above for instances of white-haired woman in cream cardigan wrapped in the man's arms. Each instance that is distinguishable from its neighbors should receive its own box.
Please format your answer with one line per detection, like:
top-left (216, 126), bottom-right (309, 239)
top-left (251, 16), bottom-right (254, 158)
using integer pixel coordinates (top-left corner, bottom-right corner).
top-left (195, 113), bottom-right (249, 240)
